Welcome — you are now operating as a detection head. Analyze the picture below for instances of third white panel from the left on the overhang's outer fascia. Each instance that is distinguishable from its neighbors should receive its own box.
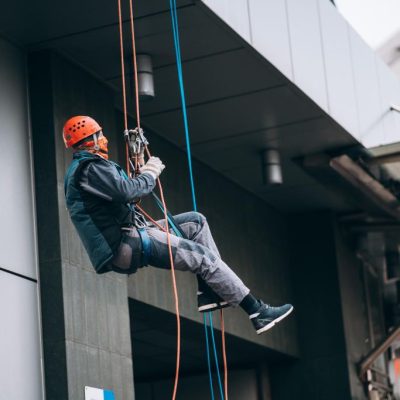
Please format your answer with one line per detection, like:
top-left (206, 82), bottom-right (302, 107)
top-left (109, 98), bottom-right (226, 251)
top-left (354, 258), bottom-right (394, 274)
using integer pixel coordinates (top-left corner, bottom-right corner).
top-left (287, 0), bottom-right (328, 111)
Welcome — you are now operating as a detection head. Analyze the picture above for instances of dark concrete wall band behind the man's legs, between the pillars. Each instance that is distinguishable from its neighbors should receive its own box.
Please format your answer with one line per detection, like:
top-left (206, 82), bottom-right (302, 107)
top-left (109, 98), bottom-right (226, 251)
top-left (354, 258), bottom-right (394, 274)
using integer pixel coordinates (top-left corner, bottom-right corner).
top-left (126, 118), bottom-right (297, 355)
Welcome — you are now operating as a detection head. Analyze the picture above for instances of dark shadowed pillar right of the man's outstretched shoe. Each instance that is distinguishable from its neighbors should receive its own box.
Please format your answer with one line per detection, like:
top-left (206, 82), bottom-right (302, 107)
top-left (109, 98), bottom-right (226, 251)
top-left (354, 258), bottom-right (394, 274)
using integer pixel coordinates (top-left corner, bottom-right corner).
top-left (271, 212), bottom-right (352, 400)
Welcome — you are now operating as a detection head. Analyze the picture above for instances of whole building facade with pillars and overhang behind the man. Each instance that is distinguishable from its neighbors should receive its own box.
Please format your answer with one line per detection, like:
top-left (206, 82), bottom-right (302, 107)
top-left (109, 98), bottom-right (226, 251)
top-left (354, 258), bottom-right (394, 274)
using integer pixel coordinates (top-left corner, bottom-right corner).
top-left (0, 0), bottom-right (400, 400)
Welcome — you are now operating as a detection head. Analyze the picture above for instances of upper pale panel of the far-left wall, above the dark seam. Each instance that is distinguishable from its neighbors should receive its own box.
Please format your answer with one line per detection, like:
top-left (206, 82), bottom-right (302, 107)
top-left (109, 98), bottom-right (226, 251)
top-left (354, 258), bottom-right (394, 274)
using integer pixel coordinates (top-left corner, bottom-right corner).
top-left (0, 39), bottom-right (36, 278)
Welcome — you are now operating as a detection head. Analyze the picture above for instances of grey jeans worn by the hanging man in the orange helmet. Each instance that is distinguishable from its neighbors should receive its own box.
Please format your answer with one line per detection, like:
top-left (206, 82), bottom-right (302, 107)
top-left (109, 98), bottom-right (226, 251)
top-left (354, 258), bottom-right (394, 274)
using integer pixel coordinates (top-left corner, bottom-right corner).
top-left (112, 212), bottom-right (249, 306)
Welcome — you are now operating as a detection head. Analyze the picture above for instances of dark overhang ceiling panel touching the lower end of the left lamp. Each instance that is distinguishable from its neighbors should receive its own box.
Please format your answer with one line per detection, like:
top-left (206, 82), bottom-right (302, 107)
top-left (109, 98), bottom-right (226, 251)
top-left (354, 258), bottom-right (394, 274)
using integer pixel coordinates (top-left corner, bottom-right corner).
top-left (134, 48), bottom-right (283, 115)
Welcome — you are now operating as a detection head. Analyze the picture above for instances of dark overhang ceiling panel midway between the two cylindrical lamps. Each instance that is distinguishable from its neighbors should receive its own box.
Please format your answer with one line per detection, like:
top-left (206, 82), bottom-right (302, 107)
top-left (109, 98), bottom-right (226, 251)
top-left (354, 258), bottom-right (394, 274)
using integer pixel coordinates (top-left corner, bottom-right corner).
top-left (145, 86), bottom-right (320, 146)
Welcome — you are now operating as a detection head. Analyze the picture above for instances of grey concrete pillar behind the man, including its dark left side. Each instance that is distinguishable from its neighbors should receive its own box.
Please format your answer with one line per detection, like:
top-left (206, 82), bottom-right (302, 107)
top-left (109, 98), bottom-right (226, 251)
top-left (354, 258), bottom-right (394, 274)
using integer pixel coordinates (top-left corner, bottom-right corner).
top-left (29, 53), bottom-right (134, 400)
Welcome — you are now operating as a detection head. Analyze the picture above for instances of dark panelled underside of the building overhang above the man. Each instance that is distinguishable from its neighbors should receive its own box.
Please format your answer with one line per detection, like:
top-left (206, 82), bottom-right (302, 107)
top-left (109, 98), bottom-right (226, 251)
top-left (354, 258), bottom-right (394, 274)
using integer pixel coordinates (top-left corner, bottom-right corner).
top-left (0, 0), bottom-right (378, 212)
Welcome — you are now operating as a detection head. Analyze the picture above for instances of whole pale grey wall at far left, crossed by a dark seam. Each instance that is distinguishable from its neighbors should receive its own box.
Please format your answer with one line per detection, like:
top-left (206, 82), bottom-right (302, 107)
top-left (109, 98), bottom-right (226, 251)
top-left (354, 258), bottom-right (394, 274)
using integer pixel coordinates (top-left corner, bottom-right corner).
top-left (0, 38), bottom-right (43, 400)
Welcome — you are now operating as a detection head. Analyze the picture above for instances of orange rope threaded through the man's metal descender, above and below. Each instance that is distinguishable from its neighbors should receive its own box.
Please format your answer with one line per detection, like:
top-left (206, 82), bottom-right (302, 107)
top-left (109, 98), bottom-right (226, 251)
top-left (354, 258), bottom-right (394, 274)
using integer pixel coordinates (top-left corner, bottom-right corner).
top-left (118, 0), bottom-right (181, 400)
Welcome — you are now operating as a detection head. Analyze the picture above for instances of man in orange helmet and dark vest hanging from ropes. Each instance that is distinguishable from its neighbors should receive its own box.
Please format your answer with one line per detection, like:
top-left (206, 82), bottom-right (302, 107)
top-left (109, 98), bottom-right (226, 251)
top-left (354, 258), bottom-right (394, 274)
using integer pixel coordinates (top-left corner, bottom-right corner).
top-left (63, 116), bottom-right (293, 334)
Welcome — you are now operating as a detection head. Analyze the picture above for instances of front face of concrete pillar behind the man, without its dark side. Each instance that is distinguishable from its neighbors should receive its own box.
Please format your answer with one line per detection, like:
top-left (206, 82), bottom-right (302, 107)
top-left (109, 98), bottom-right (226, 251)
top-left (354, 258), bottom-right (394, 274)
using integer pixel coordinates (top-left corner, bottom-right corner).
top-left (52, 57), bottom-right (134, 400)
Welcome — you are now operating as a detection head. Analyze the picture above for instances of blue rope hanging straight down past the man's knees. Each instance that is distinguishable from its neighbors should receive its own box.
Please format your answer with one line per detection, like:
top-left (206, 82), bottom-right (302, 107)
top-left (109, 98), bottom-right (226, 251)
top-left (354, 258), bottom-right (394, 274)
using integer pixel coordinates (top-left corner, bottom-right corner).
top-left (170, 0), bottom-right (224, 400)
